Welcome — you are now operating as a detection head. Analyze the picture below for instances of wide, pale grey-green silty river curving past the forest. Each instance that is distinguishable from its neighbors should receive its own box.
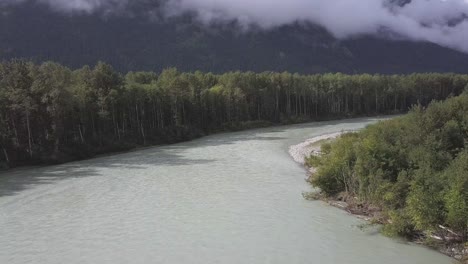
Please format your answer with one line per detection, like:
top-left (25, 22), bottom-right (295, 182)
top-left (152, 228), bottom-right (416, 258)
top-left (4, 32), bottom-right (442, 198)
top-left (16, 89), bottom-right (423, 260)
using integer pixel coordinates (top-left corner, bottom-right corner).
top-left (0, 118), bottom-right (453, 264)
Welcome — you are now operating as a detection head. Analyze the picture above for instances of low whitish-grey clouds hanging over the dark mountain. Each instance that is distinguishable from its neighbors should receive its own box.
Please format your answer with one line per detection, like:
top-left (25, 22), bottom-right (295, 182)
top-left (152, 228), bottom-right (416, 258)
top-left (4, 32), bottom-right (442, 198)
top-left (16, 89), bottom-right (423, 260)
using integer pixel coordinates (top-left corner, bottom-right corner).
top-left (0, 0), bottom-right (468, 53)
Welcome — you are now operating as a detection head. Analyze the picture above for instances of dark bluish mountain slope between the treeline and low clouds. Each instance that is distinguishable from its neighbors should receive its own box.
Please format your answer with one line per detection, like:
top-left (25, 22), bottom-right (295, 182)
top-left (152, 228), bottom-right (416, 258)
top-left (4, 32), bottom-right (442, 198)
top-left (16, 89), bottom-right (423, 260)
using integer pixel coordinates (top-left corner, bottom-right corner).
top-left (0, 1), bottom-right (468, 73)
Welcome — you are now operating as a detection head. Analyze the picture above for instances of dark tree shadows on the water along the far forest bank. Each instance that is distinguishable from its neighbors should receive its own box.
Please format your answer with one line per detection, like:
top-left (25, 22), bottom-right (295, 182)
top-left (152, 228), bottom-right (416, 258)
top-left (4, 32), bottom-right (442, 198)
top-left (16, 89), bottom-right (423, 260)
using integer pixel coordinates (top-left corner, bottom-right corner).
top-left (0, 118), bottom-right (386, 197)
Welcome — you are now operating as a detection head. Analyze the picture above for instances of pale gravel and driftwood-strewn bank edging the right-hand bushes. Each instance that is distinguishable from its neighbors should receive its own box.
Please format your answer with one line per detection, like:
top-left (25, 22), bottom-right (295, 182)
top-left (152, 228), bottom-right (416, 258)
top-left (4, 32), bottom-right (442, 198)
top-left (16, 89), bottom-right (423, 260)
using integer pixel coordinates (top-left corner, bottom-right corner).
top-left (289, 131), bottom-right (468, 264)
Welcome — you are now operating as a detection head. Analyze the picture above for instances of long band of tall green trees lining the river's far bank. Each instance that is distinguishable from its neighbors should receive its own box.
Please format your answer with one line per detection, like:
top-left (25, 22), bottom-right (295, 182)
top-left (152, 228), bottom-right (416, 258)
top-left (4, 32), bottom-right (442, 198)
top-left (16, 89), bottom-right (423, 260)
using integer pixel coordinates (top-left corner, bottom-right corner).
top-left (0, 60), bottom-right (468, 168)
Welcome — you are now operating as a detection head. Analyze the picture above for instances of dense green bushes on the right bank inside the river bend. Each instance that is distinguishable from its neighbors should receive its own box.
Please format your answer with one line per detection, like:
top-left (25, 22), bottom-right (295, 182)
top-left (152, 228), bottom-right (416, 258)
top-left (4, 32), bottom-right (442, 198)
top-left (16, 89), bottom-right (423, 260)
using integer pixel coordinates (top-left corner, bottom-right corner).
top-left (305, 92), bottom-right (468, 263)
